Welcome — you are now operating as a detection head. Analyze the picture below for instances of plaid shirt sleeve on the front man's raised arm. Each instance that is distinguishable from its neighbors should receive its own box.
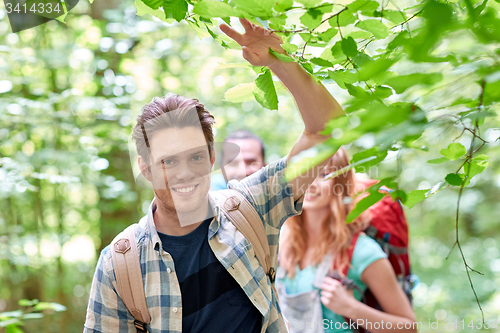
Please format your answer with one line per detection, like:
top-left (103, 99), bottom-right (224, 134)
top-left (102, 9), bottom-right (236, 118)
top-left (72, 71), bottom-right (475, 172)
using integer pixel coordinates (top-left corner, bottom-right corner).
top-left (228, 156), bottom-right (304, 229)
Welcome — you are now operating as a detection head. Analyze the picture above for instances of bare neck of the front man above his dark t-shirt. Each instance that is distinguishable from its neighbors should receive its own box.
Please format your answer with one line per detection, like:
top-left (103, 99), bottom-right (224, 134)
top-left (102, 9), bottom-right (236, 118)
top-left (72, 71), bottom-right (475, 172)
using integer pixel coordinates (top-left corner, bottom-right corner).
top-left (153, 200), bottom-right (211, 236)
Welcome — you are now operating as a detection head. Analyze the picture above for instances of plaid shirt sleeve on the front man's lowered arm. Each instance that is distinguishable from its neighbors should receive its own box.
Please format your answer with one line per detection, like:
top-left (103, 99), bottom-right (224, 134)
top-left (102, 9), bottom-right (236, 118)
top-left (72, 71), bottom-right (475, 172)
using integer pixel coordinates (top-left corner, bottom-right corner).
top-left (83, 246), bottom-right (136, 333)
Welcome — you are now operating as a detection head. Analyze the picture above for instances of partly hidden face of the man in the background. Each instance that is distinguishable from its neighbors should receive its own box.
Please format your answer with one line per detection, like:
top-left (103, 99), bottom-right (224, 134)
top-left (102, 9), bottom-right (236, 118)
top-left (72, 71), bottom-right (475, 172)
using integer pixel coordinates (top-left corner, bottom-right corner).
top-left (222, 139), bottom-right (264, 181)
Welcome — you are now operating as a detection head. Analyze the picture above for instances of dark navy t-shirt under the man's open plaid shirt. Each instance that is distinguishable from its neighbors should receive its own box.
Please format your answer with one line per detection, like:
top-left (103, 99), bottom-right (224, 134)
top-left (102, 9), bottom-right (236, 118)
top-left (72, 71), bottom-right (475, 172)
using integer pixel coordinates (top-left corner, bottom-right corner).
top-left (158, 218), bottom-right (262, 333)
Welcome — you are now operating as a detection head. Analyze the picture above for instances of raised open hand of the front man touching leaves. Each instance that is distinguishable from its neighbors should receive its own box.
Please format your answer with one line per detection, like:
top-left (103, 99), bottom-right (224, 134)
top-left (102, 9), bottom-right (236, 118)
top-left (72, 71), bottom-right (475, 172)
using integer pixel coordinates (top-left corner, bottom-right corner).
top-left (220, 18), bottom-right (285, 67)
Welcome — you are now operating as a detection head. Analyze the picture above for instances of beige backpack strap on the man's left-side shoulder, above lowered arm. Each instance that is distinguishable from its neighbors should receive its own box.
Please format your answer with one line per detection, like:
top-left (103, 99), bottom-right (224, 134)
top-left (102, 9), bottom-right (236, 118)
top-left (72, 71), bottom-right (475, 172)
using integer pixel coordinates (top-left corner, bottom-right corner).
top-left (111, 225), bottom-right (151, 333)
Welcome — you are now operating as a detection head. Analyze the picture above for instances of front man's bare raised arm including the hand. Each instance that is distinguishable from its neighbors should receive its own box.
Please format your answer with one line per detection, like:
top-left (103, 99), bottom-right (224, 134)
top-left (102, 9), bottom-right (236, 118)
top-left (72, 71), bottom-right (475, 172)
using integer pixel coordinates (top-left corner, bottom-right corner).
top-left (220, 19), bottom-right (344, 200)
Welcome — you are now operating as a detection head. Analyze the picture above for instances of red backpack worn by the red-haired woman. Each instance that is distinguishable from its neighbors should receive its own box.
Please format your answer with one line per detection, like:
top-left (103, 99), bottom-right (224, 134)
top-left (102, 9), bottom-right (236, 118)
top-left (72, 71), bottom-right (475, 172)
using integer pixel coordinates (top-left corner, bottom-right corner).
top-left (333, 181), bottom-right (413, 333)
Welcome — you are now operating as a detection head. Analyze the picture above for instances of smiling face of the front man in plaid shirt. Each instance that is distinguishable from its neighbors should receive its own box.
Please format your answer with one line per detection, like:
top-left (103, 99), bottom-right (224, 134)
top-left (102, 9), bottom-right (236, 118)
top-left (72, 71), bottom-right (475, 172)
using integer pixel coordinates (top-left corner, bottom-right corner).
top-left (139, 127), bottom-right (214, 214)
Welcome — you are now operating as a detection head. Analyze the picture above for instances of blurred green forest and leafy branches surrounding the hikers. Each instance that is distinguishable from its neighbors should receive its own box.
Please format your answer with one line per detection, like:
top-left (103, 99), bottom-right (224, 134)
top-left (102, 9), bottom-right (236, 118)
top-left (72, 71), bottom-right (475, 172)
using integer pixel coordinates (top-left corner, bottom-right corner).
top-left (0, 0), bottom-right (500, 332)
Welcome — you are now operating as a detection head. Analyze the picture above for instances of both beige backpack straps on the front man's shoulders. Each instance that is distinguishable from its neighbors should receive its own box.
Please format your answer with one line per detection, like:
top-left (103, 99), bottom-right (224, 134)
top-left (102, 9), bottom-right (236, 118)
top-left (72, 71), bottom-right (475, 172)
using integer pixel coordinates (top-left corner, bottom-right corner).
top-left (111, 189), bottom-right (278, 333)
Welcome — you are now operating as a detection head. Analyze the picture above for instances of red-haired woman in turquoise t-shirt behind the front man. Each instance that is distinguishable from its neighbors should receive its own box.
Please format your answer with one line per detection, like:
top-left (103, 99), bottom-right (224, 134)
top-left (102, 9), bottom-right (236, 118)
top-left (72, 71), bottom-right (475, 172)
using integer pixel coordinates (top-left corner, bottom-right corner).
top-left (276, 149), bottom-right (416, 333)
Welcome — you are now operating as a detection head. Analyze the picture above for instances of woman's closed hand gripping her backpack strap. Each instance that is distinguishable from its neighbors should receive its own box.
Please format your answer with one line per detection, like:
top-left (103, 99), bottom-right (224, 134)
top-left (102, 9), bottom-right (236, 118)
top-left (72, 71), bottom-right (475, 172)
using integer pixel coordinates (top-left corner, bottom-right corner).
top-left (320, 276), bottom-right (356, 316)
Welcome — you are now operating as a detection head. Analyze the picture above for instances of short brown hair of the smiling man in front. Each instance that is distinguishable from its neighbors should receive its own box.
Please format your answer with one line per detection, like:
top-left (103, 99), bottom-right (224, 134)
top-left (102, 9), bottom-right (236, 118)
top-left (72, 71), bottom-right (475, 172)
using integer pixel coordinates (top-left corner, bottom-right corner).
top-left (132, 93), bottom-right (215, 164)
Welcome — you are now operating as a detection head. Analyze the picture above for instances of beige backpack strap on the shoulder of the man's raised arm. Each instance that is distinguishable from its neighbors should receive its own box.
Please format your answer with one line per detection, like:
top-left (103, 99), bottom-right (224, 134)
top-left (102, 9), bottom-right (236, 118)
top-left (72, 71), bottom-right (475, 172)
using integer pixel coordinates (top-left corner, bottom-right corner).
top-left (215, 189), bottom-right (277, 286)
